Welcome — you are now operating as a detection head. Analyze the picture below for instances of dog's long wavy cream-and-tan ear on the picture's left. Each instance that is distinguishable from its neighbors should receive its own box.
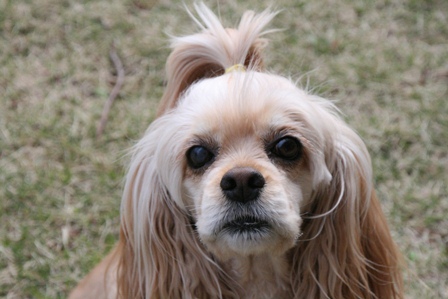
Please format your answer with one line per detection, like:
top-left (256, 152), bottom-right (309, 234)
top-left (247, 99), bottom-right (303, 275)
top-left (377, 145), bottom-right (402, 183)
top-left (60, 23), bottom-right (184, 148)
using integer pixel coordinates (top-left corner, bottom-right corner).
top-left (117, 132), bottom-right (236, 298)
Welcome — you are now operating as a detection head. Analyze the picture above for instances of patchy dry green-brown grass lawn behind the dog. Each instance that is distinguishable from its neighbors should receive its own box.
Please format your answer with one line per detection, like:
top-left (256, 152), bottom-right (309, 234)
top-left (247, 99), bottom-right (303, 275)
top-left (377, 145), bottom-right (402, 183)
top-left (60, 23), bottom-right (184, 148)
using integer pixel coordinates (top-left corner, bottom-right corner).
top-left (0, 0), bottom-right (448, 298)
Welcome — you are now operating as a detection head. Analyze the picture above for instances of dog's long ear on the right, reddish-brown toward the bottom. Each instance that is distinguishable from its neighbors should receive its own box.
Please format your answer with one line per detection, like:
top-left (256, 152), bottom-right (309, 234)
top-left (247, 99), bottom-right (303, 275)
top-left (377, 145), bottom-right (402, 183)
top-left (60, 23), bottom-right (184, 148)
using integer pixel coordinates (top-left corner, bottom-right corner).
top-left (292, 122), bottom-right (403, 299)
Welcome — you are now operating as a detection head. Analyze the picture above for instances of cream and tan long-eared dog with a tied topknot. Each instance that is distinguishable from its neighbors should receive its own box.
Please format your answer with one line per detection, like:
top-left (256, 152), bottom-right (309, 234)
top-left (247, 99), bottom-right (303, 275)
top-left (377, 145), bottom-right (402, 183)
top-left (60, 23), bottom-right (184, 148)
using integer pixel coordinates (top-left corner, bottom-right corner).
top-left (70, 3), bottom-right (403, 299)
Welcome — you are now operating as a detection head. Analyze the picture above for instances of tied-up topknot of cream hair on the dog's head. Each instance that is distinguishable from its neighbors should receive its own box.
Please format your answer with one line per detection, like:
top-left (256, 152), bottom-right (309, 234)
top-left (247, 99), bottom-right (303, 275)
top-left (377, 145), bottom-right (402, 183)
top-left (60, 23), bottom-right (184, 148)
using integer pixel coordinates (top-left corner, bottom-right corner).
top-left (157, 2), bottom-right (277, 116)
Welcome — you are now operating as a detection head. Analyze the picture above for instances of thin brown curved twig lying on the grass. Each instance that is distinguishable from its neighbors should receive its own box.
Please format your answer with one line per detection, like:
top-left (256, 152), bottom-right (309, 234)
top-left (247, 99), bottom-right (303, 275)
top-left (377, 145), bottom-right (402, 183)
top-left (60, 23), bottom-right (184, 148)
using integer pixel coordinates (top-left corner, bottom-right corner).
top-left (96, 45), bottom-right (124, 139)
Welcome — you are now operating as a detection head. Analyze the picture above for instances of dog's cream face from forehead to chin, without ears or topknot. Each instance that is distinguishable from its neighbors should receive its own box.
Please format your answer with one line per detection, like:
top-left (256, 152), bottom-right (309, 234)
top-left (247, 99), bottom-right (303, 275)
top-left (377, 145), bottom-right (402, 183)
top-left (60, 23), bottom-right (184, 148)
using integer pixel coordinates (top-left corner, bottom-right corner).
top-left (155, 72), bottom-right (330, 258)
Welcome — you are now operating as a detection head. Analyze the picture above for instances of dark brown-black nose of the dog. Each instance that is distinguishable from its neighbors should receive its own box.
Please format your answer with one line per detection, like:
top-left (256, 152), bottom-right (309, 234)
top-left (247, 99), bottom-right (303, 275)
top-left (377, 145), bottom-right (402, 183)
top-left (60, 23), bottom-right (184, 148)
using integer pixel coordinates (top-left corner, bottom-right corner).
top-left (220, 167), bottom-right (266, 203)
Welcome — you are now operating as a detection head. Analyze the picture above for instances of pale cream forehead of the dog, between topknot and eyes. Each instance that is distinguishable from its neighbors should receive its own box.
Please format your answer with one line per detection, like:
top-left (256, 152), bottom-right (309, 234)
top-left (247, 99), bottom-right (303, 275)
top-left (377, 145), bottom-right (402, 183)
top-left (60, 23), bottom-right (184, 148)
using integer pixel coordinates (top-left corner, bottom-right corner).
top-left (181, 72), bottom-right (295, 138)
